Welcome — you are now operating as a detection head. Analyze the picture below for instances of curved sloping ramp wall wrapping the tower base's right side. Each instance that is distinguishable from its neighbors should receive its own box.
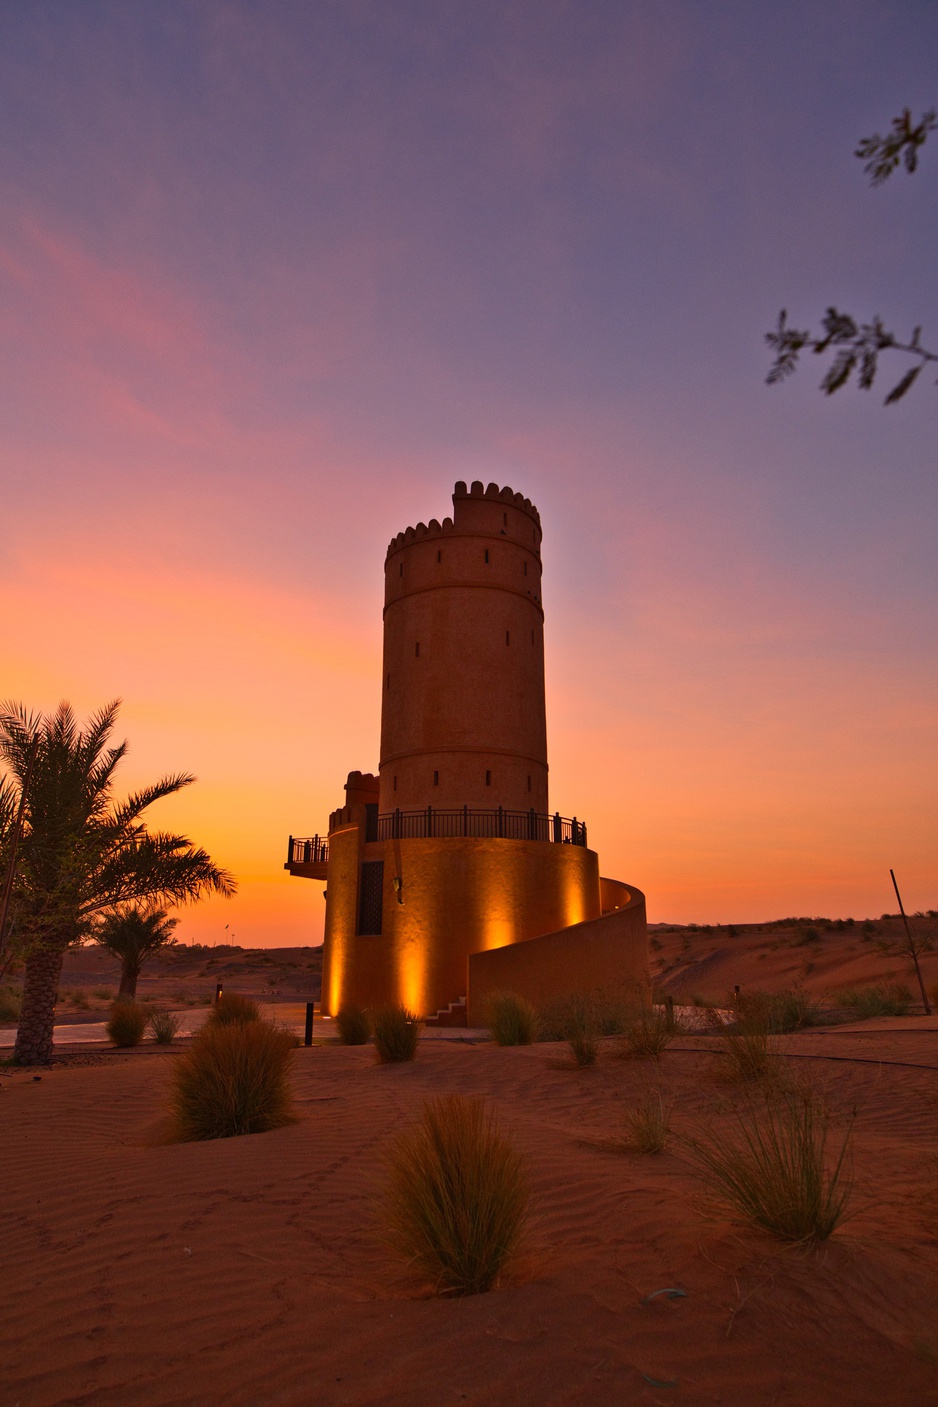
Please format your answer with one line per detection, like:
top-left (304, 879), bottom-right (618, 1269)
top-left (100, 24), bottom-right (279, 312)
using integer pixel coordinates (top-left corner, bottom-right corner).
top-left (468, 881), bottom-right (648, 1026)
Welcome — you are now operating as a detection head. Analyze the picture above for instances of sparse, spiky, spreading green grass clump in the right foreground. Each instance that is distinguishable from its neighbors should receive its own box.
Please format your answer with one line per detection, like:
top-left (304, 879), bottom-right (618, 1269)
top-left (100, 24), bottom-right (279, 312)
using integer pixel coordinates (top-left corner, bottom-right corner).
top-left (683, 1089), bottom-right (852, 1242)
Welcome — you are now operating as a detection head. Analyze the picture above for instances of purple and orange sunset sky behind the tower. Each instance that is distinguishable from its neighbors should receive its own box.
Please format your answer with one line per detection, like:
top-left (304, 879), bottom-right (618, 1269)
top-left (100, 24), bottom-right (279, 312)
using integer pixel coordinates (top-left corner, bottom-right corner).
top-left (0, 0), bottom-right (938, 946)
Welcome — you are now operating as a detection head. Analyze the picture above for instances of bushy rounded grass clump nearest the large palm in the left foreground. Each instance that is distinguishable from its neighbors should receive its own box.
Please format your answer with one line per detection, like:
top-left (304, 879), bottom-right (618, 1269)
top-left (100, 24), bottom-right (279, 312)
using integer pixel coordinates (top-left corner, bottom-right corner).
top-left (170, 1021), bottom-right (295, 1142)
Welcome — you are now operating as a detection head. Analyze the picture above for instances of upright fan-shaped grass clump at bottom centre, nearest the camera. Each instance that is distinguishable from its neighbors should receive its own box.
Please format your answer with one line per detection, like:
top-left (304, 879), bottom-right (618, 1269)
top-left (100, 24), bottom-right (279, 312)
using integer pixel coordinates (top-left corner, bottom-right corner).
top-left (384, 1095), bottom-right (529, 1294)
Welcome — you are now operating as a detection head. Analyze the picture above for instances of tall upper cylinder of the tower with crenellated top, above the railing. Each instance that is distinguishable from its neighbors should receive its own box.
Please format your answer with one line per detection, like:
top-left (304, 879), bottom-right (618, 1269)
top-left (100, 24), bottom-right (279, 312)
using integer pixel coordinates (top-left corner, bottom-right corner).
top-left (380, 481), bottom-right (548, 813)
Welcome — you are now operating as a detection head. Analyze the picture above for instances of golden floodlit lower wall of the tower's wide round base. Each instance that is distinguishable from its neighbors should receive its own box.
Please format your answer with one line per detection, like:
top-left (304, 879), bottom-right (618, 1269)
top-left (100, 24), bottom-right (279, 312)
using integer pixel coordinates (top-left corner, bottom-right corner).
top-left (322, 832), bottom-right (600, 1016)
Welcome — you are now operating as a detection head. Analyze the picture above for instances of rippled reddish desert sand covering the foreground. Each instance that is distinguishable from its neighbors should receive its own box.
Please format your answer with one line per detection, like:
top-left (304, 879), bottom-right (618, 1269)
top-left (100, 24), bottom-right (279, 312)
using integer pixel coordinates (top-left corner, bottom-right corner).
top-left (0, 1017), bottom-right (938, 1407)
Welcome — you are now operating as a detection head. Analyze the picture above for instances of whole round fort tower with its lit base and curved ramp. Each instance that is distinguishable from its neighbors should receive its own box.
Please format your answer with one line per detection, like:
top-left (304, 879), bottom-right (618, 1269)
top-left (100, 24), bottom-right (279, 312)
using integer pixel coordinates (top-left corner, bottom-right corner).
top-left (285, 483), bottom-right (647, 1023)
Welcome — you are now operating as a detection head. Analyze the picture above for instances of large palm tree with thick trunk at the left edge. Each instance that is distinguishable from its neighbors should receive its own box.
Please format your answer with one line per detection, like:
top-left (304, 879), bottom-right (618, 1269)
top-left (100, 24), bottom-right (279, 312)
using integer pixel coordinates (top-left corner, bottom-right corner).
top-left (0, 699), bottom-right (236, 1065)
